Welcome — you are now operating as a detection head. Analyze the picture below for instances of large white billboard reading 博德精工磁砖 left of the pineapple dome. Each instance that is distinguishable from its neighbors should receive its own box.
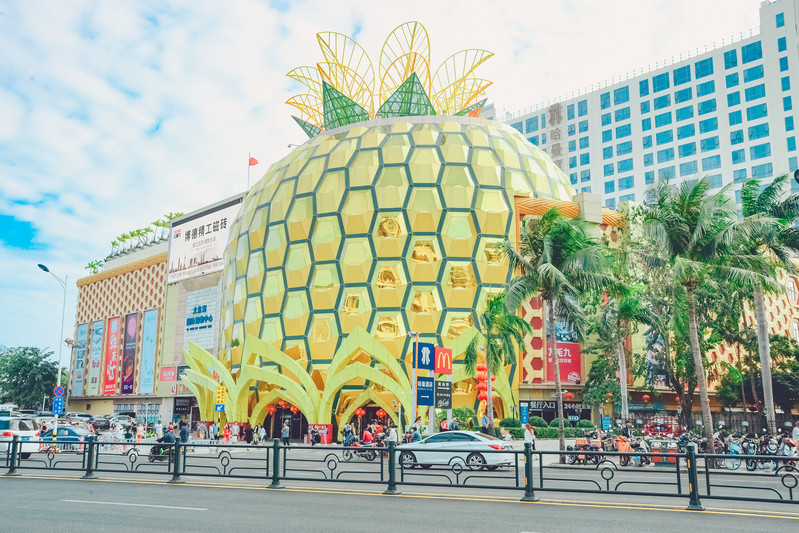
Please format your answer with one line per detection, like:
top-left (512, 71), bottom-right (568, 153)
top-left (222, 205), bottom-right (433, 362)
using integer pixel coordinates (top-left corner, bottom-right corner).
top-left (166, 198), bottom-right (241, 283)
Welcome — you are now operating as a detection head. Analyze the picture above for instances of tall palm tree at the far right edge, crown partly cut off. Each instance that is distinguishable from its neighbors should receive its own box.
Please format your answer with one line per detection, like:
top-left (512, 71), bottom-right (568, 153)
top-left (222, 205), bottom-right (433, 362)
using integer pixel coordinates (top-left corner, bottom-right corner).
top-left (741, 174), bottom-right (799, 432)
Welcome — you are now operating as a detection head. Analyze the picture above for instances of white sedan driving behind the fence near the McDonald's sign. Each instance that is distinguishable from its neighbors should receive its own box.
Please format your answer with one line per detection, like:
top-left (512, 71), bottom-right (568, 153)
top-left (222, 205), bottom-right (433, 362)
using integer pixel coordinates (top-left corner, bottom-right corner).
top-left (397, 431), bottom-right (514, 470)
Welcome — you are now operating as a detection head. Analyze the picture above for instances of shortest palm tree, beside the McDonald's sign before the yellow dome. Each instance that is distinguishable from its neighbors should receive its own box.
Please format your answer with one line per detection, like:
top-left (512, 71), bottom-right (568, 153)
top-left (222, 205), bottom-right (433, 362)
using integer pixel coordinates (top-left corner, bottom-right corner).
top-left (463, 292), bottom-right (532, 435)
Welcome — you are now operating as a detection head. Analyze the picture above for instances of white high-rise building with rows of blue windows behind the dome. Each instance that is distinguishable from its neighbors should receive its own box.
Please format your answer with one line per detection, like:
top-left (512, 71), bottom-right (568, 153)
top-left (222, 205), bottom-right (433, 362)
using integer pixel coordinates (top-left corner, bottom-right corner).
top-left (494, 0), bottom-right (799, 208)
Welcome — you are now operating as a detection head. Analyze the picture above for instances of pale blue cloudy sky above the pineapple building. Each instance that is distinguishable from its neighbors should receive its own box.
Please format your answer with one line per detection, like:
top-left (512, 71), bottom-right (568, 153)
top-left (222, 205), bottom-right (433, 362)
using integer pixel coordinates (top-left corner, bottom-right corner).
top-left (0, 0), bottom-right (764, 360)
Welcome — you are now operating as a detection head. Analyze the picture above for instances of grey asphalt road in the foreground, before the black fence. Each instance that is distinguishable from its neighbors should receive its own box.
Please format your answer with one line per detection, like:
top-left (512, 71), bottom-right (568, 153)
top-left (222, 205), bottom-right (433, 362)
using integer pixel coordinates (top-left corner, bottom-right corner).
top-left (0, 472), bottom-right (799, 533)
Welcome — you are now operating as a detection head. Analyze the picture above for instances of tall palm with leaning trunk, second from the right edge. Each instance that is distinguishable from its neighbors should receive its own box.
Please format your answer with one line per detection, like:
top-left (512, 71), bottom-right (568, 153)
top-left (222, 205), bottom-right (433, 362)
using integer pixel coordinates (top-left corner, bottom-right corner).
top-left (643, 178), bottom-right (759, 453)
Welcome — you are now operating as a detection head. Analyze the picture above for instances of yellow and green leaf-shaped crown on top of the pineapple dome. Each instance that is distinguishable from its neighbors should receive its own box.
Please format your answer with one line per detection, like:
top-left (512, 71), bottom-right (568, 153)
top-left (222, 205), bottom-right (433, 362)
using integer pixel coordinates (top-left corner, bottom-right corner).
top-left (286, 22), bottom-right (494, 137)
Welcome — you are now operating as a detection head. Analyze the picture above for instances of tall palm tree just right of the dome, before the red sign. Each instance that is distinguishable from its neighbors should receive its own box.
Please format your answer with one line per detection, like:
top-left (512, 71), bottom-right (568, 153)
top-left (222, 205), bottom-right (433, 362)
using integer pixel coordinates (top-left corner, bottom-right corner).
top-left (505, 208), bottom-right (614, 448)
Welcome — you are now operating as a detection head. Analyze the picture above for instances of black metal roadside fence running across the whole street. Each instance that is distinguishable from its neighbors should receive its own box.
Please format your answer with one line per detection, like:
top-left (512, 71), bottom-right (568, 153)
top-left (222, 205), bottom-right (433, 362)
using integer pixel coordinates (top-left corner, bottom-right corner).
top-left (0, 436), bottom-right (799, 509)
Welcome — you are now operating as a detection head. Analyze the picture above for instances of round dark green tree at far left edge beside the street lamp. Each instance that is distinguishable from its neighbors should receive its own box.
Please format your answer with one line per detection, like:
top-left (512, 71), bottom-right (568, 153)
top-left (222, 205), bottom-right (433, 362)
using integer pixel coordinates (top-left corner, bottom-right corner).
top-left (0, 346), bottom-right (68, 409)
